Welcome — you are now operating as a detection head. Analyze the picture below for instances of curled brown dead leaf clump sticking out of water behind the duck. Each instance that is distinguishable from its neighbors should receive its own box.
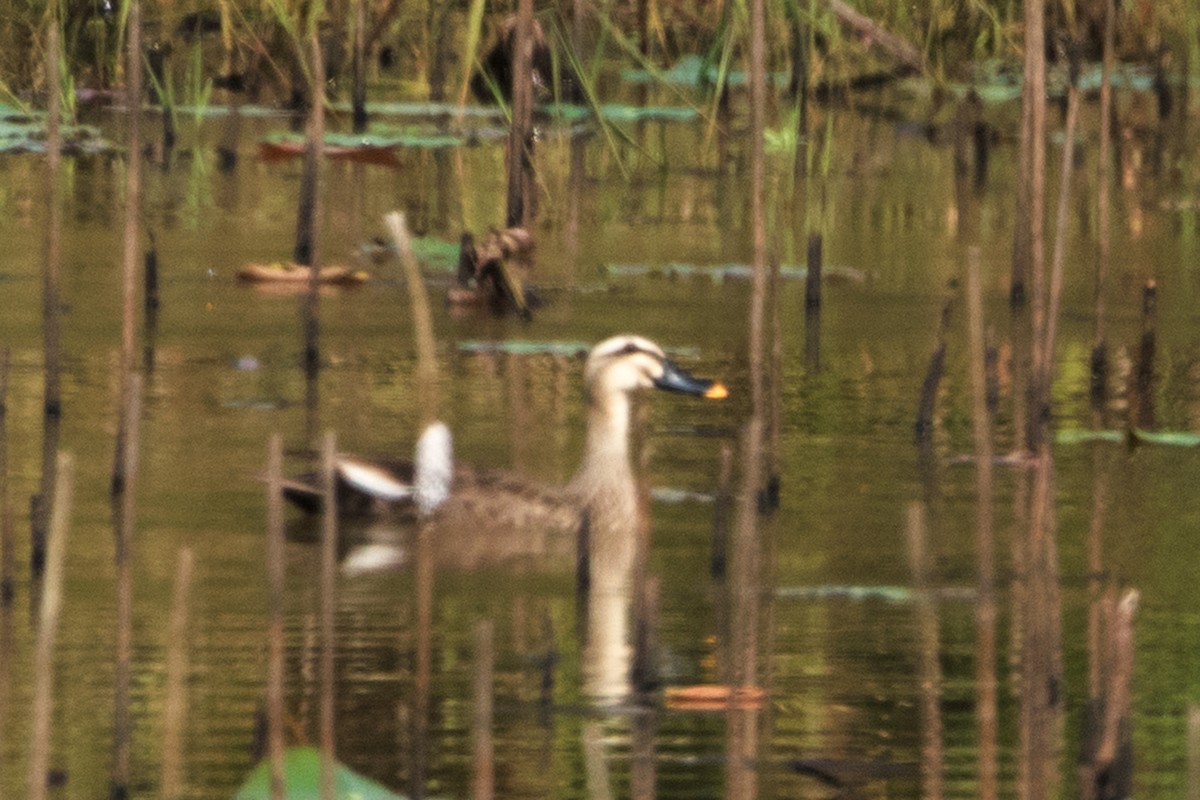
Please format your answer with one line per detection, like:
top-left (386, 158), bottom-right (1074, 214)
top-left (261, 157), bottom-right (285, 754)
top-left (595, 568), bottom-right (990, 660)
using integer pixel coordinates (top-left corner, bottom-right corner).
top-left (446, 227), bottom-right (536, 320)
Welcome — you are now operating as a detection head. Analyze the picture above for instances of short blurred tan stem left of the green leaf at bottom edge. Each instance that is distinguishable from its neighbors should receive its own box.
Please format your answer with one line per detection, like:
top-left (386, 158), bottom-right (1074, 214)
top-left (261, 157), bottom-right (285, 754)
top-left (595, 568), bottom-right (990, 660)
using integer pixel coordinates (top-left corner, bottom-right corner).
top-left (160, 547), bottom-right (196, 800)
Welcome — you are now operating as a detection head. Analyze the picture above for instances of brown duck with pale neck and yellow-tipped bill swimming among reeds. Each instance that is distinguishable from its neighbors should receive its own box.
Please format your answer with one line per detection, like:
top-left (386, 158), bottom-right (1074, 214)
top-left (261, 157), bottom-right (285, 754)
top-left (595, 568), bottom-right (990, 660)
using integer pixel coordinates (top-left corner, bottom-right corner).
top-left (284, 333), bottom-right (728, 578)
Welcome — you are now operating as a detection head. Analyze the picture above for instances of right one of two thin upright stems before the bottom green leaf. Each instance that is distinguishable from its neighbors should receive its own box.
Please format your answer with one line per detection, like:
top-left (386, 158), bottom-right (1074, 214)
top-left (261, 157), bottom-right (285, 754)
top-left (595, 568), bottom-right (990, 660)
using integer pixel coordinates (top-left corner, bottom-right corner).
top-left (320, 431), bottom-right (337, 800)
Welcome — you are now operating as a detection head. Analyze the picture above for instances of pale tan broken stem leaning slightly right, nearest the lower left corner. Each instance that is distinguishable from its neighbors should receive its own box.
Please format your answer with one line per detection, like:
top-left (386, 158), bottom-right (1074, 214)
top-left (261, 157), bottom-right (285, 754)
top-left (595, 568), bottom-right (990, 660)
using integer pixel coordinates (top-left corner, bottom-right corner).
top-left (26, 453), bottom-right (74, 800)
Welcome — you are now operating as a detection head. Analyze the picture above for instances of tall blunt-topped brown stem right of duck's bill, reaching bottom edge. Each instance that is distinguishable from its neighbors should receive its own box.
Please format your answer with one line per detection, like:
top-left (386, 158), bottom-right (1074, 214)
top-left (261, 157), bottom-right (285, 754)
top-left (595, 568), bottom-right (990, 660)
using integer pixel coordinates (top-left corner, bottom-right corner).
top-left (967, 246), bottom-right (997, 800)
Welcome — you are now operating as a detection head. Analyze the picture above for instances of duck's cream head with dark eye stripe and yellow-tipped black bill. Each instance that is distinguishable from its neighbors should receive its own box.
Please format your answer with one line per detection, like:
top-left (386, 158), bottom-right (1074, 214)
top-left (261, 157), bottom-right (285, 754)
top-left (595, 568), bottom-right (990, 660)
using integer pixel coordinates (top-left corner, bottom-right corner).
top-left (583, 335), bottom-right (728, 399)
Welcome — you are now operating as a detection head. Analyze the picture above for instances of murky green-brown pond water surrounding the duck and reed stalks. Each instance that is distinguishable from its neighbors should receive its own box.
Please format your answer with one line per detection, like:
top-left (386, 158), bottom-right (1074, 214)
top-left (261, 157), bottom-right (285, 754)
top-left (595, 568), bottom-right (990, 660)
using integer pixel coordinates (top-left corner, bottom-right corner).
top-left (0, 84), bottom-right (1200, 799)
